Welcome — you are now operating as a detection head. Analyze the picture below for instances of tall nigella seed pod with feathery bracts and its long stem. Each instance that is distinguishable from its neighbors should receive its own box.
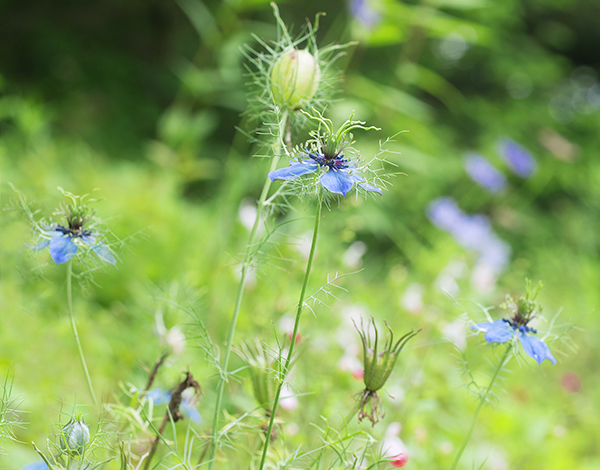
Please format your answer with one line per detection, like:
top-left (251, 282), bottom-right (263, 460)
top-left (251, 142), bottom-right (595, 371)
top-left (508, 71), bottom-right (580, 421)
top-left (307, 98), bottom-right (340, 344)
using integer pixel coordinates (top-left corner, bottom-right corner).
top-left (208, 11), bottom-right (350, 470)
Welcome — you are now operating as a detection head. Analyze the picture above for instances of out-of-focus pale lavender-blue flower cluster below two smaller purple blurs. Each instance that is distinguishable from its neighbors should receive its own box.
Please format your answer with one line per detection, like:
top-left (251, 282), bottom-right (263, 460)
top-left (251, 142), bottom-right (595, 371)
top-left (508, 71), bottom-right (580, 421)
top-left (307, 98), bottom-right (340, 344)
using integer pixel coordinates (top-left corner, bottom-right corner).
top-left (426, 196), bottom-right (512, 273)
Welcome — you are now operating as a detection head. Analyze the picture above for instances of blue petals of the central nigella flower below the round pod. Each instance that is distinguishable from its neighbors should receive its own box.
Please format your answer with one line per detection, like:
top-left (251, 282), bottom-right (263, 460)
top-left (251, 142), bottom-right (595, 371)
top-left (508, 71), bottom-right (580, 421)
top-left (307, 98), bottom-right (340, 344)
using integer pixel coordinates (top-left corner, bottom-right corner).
top-left (269, 151), bottom-right (382, 196)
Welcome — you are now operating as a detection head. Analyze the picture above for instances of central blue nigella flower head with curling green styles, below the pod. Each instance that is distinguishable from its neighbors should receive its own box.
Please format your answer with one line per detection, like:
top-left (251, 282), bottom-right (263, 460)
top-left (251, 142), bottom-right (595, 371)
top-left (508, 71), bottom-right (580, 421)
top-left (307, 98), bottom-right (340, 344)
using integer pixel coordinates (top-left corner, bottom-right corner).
top-left (269, 109), bottom-right (382, 196)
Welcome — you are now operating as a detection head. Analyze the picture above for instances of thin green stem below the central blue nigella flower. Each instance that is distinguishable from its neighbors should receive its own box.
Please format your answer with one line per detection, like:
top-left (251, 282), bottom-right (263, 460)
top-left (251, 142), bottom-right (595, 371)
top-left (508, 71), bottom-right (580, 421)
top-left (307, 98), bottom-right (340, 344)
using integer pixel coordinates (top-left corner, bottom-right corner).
top-left (258, 194), bottom-right (323, 470)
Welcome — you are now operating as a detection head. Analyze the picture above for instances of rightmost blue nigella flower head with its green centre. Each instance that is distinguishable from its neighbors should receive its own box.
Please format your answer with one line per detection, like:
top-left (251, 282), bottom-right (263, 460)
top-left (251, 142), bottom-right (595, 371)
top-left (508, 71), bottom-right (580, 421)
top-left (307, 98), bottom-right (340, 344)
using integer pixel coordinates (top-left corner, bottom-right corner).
top-left (471, 280), bottom-right (556, 364)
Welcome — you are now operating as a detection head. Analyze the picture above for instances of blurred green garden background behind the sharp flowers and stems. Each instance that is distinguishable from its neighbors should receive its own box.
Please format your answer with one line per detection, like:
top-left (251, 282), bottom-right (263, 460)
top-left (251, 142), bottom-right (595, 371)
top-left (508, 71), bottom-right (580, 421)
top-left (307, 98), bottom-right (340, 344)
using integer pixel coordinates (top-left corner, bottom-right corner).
top-left (0, 0), bottom-right (600, 470)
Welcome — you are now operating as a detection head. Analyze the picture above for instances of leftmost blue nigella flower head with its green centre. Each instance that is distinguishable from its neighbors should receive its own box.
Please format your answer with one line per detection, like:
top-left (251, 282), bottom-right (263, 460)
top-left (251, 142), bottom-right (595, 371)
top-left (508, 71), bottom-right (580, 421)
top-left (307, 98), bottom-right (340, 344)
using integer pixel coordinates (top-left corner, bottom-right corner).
top-left (31, 190), bottom-right (117, 266)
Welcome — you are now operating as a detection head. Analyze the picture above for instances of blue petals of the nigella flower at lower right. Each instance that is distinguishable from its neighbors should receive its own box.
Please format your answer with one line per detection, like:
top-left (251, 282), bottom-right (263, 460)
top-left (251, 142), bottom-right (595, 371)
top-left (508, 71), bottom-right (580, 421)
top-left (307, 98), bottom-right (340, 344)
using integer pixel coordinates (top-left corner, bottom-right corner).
top-left (471, 319), bottom-right (556, 364)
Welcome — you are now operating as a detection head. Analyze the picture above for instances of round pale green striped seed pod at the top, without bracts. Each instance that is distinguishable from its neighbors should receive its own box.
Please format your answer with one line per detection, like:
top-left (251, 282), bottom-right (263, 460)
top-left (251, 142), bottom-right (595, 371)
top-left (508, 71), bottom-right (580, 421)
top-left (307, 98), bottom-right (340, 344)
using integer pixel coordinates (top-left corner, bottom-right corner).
top-left (271, 49), bottom-right (321, 109)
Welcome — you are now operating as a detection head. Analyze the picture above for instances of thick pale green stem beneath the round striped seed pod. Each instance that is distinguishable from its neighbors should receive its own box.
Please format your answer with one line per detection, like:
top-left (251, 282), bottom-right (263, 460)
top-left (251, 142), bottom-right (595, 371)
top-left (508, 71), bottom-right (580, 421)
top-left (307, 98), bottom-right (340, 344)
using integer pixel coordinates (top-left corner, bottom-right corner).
top-left (208, 111), bottom-right (288, 470)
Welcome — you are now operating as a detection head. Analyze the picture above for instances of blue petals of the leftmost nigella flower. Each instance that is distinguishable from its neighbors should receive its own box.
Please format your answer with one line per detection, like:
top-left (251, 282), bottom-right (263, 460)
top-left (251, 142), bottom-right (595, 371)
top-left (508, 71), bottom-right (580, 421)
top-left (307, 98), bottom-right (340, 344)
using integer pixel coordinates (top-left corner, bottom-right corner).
top-left (31, 225), bottom-right (117, 266)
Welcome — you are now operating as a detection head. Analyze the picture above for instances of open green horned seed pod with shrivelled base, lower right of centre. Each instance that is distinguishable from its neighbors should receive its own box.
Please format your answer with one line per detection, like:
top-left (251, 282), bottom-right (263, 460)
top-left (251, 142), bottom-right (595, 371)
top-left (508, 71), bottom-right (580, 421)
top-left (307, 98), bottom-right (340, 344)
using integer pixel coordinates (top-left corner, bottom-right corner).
top-left (355, 317), bottom-right (420, 426)
